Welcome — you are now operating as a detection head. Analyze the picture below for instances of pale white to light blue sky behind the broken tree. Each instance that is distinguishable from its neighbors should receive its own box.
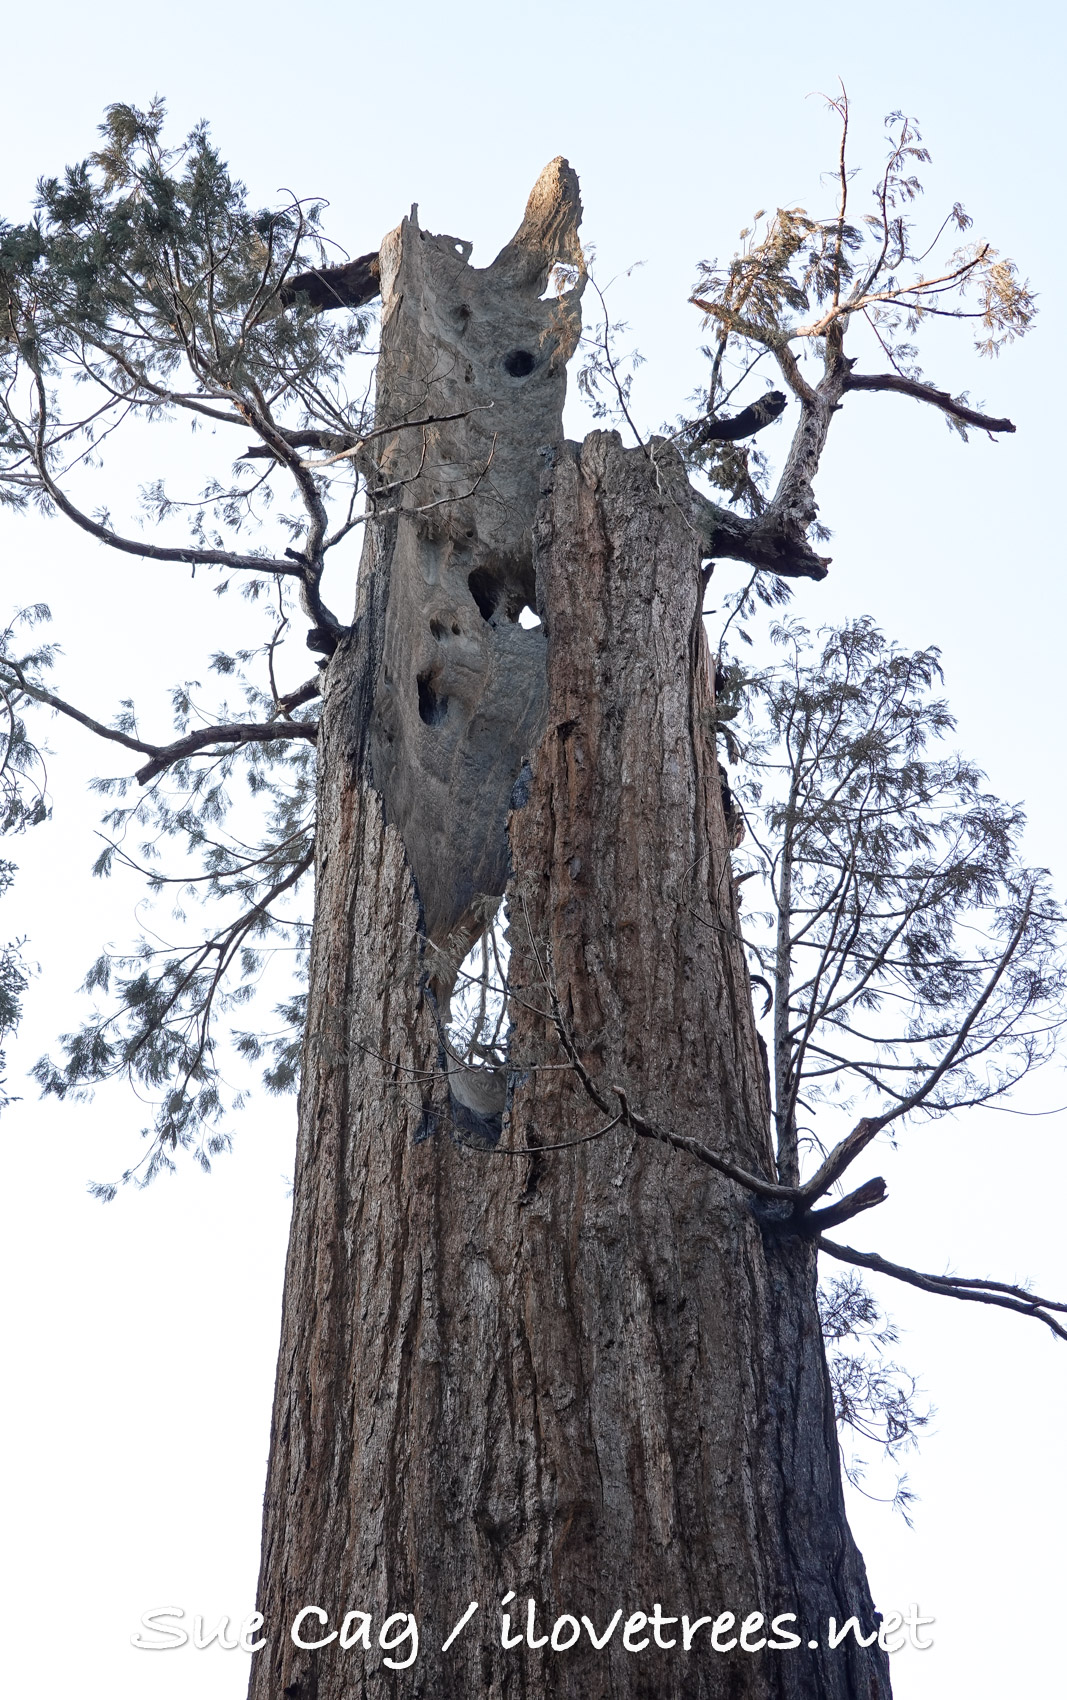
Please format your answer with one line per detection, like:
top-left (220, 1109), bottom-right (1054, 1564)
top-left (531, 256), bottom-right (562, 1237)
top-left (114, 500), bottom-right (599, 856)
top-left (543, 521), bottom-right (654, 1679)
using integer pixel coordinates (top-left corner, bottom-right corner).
top-left (0, 0), bottom-right (1067, 1700)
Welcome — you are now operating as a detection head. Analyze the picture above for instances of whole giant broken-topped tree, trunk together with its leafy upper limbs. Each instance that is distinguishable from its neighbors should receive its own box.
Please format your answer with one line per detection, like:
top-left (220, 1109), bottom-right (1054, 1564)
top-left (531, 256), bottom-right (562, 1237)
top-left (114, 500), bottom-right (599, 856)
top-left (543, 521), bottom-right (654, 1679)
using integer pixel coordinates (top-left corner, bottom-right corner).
top-left (0, 102), bottom-right (1053, 1700)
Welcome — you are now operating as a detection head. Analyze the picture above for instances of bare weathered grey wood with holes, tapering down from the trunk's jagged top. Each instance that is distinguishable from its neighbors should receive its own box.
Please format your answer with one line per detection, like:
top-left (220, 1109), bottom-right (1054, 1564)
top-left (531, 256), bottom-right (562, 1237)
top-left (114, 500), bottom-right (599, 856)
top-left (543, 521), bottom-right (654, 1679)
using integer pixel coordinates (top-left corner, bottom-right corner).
top-left (370, 160), bottom-right (581, 998)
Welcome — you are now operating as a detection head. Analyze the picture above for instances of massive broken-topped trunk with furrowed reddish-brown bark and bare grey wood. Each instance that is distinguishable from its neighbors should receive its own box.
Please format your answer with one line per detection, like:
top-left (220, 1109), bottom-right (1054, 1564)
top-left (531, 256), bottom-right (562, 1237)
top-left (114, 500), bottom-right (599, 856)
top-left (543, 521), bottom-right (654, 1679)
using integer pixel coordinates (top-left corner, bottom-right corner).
top-left (251, 162), bottom-right (889, 1700)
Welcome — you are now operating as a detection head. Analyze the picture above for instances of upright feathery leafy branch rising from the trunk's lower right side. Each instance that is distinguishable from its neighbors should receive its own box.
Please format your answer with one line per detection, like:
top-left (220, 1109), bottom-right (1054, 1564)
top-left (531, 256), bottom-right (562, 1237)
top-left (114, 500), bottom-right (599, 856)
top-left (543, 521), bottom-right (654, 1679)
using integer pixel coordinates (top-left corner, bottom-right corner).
top-left (715, 619), bottom-right (1067, 1298)
